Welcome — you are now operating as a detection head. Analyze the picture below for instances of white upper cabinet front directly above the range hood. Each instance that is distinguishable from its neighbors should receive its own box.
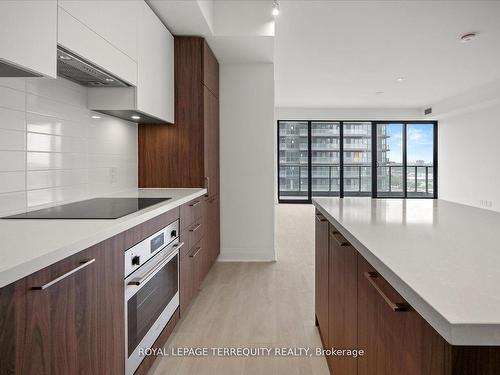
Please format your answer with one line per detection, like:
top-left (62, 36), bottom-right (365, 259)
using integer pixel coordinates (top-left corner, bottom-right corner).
top-left (57, 0), bottom-right (139, 86)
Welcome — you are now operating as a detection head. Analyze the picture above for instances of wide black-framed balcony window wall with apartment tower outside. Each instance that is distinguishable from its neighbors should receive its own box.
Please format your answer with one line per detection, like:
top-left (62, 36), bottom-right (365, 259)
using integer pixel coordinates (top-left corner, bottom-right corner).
top-left (278, 121), bottom-right (437, 202)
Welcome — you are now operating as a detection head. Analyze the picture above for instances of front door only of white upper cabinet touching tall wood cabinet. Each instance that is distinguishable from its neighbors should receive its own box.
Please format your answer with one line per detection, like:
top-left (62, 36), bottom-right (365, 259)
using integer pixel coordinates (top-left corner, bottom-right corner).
top-left (137, 3), bottom-right (174, 123)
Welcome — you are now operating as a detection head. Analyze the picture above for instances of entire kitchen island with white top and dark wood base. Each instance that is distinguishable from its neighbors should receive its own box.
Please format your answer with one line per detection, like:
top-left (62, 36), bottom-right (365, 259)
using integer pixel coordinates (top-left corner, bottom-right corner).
top-left (313, 198), bottom-right (500, 374)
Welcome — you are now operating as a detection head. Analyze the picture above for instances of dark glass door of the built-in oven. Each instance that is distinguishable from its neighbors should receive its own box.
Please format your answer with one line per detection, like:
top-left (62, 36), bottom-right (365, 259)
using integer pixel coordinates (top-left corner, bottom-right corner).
top-left (127, 254), bottom-right (179, 357)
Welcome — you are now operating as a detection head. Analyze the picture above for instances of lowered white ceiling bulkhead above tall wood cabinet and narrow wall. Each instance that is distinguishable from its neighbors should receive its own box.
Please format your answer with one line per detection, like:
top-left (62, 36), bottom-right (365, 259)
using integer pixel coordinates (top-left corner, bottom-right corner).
top-left (147, 0), bottom-right (274, 63)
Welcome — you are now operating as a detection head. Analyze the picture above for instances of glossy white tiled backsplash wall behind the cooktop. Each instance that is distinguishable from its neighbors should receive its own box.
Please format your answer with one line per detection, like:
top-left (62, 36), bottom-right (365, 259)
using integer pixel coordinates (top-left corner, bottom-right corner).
top-left (0, 78), bottom-right (137, 216)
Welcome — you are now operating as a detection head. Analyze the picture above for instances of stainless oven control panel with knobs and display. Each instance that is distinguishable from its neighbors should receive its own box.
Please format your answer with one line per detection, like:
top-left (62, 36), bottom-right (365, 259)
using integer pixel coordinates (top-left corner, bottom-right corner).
top-left (125, 220), bottom-right (179, 277)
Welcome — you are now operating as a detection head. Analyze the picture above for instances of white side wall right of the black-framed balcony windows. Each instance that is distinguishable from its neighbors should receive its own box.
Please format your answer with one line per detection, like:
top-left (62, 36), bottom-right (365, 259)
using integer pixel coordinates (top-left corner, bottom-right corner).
top-left (438, 103), bottom-right (500, 211)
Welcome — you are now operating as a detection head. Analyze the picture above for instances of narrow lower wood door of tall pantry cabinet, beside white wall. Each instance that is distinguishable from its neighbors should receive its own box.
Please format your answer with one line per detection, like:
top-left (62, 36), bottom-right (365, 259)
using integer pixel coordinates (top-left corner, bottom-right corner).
top-left (203, 87), bottom-right (219, 197)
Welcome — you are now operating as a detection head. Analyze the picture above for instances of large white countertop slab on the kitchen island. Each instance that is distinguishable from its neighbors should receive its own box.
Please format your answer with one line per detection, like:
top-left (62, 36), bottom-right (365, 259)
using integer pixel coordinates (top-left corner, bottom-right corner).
top-left (313, 198), bottom-right (500, 345)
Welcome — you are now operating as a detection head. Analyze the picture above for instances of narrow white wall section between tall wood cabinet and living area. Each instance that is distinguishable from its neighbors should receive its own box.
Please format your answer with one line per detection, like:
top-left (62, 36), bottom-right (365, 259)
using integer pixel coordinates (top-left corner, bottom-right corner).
top-left (219, 64), bottom-right (275, 261)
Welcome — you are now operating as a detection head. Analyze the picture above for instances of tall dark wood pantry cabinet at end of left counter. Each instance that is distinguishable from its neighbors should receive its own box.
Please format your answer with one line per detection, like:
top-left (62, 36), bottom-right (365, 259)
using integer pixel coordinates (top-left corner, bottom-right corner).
top-left (139, 37), bottom-right (219, 197)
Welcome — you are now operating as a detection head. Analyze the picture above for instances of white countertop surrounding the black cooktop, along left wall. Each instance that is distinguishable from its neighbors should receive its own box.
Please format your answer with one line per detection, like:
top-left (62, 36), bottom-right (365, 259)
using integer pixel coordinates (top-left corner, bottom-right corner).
top-left (0, 189), bottom-right (206, 288)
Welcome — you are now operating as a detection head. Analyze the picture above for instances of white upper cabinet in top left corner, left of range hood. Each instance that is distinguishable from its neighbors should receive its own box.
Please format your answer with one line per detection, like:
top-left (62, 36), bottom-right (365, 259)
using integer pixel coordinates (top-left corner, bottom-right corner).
top-left (0, 0), bottom-right (57, 78)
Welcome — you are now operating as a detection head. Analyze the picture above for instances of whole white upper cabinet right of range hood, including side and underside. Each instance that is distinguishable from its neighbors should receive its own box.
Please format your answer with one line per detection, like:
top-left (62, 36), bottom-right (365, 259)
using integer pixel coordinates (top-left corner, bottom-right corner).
top-left (88, 1), bottom-right (174, 123)
